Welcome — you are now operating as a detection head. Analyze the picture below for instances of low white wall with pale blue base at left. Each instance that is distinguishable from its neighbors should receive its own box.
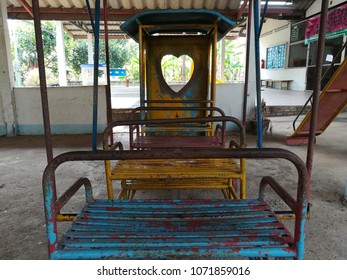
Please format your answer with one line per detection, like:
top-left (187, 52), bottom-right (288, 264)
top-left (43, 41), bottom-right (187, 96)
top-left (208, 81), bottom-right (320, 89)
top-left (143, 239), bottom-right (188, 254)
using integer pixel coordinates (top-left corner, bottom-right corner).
top-left (15, 86), bottom-right (107, 135)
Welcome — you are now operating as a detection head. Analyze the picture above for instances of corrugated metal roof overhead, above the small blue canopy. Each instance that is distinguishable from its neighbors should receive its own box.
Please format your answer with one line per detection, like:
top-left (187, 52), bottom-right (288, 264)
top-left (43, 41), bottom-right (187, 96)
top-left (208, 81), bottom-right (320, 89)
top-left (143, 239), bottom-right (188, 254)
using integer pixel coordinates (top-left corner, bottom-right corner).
top-left (6, 0), bottom-right (315, 38)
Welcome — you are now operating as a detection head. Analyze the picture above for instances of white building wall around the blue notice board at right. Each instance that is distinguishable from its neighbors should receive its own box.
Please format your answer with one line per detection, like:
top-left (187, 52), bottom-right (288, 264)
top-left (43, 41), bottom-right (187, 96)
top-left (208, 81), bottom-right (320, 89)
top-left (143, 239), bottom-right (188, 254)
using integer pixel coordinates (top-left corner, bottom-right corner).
top-left (260, 19), bottom-right (306, 91)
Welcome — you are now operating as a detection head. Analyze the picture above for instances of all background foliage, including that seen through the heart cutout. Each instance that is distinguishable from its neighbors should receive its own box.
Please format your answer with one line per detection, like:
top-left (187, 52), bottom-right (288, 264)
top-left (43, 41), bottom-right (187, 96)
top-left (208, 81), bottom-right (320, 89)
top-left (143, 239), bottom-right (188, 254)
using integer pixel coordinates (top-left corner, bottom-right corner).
top-left (11, 21), bottom-right (244, 84)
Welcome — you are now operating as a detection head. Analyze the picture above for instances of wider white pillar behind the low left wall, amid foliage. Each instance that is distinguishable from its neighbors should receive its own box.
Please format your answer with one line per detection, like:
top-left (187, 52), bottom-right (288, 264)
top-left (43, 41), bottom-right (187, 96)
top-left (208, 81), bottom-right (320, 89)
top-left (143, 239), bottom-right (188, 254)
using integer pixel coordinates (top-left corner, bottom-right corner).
top-left (56, 21), bottom-right (67, 86)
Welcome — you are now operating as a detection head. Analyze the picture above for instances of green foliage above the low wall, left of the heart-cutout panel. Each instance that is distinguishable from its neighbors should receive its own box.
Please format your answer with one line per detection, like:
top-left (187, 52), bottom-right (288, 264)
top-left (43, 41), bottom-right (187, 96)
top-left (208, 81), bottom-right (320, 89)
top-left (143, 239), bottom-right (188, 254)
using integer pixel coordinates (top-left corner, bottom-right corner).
top-left (11, 21), bottom-right (130, 84)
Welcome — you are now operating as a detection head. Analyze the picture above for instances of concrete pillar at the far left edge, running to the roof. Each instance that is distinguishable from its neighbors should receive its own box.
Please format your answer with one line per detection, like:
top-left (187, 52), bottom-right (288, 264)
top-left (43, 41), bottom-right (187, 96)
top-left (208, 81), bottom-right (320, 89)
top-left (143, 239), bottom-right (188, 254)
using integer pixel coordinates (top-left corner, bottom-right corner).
top-left (0, 1), bottom-right (16, 136)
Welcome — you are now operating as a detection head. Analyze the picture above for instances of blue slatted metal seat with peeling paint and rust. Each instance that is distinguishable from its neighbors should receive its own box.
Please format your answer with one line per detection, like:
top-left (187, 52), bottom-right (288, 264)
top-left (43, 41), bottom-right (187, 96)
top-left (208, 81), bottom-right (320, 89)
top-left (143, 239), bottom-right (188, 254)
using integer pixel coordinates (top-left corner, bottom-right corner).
top-left (52, 200), bottom-right (296, 259)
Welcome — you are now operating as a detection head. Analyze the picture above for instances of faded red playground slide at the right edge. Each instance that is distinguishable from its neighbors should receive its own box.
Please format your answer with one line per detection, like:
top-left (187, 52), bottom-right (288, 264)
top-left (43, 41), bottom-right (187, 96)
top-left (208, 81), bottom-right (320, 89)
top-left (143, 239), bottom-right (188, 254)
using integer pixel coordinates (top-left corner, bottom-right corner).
top-left (286, 57), bottom-right (347, 145)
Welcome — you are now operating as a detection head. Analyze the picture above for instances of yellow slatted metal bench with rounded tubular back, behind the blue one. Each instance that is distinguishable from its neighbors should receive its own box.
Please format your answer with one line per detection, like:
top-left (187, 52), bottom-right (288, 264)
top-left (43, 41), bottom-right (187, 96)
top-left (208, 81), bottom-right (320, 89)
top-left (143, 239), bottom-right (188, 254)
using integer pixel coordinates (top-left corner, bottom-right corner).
top-left (103, 117), bottom-right (246, 199)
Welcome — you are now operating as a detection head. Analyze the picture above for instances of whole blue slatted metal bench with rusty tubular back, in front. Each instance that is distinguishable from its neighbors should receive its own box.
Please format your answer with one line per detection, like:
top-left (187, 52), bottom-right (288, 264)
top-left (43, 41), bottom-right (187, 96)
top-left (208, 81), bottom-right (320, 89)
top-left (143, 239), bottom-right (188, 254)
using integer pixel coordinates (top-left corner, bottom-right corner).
top-left (43, 149), bottom-right (308, 259)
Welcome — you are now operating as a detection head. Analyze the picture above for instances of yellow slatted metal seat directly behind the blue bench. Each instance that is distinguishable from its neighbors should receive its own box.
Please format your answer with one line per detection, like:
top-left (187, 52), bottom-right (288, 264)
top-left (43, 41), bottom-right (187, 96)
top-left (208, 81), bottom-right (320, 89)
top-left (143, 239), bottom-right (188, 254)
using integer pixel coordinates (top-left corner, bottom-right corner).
top-left (108, 158), bottom-right (246, 199)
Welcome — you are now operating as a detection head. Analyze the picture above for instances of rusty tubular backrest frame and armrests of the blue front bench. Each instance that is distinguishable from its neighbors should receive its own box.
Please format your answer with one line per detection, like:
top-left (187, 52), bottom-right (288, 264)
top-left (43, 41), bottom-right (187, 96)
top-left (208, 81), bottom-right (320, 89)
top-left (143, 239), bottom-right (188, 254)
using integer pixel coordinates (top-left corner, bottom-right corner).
top-left (43, 148), bottom-right (308, 259)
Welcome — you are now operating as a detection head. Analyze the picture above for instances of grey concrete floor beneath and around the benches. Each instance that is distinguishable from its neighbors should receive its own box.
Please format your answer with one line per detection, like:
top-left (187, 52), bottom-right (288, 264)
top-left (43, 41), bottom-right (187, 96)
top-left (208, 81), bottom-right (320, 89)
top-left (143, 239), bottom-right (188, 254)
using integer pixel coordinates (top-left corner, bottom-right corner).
top-left (0, 113), bottom-right (347, 259)
